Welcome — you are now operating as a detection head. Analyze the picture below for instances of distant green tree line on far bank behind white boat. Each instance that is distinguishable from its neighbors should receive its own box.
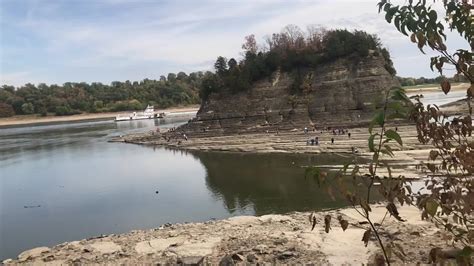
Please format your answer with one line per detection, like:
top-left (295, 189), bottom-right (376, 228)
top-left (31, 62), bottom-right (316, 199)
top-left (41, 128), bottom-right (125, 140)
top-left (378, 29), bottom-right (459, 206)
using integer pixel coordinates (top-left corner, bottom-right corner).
top-left (0, 72), bottom-right (204, 117)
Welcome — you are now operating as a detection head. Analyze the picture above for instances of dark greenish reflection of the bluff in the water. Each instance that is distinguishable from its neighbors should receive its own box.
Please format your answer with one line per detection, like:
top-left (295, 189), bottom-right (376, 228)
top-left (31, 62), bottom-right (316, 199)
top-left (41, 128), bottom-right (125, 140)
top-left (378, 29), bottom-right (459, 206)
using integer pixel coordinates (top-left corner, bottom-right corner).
top-left (194, 152), bottom-right (374, 215)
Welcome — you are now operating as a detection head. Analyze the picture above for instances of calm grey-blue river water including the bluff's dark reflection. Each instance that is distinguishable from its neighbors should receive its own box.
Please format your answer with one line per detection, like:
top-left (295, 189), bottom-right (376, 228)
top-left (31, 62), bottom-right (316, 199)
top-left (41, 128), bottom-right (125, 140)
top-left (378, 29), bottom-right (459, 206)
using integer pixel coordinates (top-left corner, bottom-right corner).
top-left (0, 117), bottom-right (356, 259)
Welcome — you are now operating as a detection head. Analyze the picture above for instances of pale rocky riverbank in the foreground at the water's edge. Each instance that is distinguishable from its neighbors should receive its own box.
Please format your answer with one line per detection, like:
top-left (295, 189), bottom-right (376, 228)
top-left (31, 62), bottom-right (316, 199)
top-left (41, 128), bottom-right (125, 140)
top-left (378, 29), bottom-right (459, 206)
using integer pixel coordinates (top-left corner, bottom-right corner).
top-left (3, 205), bottom-right (456, 265)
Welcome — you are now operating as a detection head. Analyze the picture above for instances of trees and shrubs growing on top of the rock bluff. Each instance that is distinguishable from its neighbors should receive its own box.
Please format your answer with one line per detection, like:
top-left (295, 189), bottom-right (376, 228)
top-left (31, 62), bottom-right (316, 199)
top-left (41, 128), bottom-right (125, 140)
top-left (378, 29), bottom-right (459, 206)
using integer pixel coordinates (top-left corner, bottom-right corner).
top-left (200, 25), bottom-right (396, 100)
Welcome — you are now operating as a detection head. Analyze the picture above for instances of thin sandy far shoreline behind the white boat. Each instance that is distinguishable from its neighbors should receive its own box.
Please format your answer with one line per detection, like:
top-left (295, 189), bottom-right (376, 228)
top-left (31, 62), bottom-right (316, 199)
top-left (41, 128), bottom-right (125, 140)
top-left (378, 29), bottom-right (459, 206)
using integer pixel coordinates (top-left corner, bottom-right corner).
top-left (0, 105), bottom-right (199, 127)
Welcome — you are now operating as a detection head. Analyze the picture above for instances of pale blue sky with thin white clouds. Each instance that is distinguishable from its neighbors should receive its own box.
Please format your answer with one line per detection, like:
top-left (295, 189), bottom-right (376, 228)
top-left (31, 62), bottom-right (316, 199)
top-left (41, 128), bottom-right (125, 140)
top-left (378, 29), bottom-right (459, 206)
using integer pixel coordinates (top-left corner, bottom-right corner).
top-left (0, 0), bottom-right (467, 86)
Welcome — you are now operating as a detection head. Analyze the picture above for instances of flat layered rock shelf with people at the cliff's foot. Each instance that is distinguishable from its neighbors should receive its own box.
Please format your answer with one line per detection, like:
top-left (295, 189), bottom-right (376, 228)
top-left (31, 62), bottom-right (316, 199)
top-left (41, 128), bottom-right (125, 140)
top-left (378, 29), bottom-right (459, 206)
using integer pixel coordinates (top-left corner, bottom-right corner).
top-left (111, 125), bottom-right (432, 179)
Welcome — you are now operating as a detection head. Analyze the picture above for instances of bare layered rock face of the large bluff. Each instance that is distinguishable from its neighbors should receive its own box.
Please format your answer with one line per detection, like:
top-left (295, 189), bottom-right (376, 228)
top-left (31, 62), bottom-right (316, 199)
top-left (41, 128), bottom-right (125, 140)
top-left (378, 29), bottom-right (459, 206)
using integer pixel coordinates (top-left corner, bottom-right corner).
top-left (180, 55), bottom-right (399, 135)
